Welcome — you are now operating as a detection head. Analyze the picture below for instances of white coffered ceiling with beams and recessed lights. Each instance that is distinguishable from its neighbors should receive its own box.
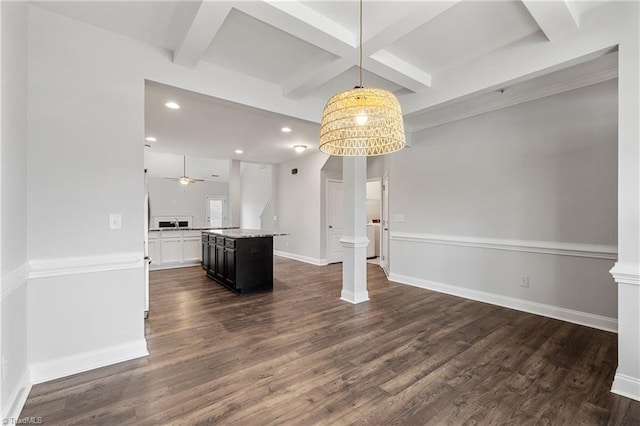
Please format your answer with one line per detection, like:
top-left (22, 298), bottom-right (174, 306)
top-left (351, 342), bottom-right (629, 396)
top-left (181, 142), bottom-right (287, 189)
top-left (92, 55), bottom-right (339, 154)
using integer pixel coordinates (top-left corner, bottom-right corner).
top-left (32, 0), bottom-right (617, 173)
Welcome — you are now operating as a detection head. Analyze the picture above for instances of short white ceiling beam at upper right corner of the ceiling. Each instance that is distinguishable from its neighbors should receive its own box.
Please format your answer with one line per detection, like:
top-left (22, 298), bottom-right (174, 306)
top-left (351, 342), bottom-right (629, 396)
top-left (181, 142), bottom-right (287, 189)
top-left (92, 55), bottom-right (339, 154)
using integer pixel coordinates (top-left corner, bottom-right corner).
top-left (522, 0), bottom-right (580, 41)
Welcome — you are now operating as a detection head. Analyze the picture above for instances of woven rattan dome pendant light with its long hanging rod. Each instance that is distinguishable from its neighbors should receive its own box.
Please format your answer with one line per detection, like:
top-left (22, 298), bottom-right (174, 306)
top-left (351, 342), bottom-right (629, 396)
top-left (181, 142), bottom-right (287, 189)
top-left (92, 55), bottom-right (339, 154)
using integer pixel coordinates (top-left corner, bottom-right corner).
top-left (320, 0), bottom-right (406, 157)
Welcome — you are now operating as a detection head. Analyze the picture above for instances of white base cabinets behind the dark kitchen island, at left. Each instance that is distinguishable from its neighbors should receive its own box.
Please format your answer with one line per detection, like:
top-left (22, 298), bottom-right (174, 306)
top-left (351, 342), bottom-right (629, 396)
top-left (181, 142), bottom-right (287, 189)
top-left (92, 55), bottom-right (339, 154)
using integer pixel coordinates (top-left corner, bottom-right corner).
top-left (149, 230), bottom-right (202, 269)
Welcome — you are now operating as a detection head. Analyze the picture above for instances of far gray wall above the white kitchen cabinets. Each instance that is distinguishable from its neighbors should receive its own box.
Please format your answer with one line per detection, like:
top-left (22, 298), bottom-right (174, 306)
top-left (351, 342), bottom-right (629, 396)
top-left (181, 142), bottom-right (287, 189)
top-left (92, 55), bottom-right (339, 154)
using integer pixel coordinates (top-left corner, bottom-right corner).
top-left (149, 177), bottom-right (229, 227)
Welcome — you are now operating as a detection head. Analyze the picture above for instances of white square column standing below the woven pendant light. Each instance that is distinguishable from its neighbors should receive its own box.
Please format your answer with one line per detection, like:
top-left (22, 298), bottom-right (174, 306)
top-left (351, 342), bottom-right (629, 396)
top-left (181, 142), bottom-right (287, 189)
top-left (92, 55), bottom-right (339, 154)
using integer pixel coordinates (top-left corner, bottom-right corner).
top-left (340, 157), bottom-right (369, 304)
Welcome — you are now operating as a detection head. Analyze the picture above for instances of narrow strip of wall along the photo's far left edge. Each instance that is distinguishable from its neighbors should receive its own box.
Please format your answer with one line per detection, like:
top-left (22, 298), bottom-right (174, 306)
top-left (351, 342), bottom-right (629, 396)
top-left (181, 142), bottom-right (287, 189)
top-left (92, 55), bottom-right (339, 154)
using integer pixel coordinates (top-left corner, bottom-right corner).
top-left (0, 2), bottom-right (29, 418)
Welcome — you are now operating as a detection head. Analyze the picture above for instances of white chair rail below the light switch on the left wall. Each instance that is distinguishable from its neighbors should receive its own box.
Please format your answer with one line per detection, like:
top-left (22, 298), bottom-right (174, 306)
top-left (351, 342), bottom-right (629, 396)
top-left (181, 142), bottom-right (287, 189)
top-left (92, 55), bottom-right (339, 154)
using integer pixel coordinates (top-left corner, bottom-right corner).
top-left (29, 252), bottom-right (144, 279)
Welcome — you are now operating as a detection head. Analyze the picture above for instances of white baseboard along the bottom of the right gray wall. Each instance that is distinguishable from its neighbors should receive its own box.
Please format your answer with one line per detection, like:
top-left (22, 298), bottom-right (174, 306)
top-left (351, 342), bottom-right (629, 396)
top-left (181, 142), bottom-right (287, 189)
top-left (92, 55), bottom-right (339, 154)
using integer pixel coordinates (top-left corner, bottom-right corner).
top-left (389, 272), bottom-right (618, 333)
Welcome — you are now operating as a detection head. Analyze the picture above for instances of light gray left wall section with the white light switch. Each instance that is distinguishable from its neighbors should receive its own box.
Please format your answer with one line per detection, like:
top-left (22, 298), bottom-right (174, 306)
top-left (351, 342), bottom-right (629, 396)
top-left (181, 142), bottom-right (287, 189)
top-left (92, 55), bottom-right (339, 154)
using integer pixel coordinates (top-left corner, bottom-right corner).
top-left (27, 7), bottom-right (147, 382)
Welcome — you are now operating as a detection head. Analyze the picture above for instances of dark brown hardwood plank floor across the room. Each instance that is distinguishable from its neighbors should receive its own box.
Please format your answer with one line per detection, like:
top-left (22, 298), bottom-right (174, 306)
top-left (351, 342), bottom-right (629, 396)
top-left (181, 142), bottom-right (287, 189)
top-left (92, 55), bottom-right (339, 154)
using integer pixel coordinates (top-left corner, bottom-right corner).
top-left (21, 257), bottom-right (640, 425)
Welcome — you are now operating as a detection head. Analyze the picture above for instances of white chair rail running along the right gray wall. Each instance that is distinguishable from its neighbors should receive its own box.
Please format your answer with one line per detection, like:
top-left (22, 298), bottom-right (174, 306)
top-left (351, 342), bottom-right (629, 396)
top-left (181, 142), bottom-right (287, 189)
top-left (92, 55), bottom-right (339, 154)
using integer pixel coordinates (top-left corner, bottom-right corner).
top-left (391, 232), bottom-right (618, 260)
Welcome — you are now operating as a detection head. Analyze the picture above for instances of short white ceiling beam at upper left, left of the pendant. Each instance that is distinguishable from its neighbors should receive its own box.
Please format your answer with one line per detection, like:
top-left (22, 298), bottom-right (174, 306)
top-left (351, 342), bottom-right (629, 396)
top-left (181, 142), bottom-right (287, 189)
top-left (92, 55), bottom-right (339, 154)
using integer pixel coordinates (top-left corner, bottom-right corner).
top-left (173, 1), bottom-right (231, 68)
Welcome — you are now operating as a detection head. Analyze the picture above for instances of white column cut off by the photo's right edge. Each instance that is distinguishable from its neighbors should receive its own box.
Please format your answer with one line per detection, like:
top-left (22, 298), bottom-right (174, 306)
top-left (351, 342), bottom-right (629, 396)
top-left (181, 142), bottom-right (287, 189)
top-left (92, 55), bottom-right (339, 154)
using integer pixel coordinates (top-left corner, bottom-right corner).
top-left (611, 2), bottom-right (640, 401)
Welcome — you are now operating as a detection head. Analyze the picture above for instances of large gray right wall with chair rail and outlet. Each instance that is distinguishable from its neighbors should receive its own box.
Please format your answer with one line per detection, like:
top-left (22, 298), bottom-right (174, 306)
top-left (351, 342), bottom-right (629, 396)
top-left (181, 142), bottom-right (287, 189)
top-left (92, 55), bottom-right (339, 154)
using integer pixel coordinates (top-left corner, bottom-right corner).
top-left (388, 80), bottom-right (617, 319)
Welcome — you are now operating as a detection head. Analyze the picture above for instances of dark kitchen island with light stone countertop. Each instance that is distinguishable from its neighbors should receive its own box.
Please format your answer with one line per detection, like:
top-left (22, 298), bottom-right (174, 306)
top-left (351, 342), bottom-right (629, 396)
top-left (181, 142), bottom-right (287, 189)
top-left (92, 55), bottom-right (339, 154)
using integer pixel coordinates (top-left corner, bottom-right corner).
top-left (202, 229), bottom-right (286, 293)
